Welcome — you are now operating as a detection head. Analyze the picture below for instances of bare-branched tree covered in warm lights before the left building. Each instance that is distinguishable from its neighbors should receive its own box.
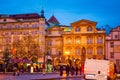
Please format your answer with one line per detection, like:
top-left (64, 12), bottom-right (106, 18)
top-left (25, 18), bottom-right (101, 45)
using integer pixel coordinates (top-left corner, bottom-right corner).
top-left (13, 35), bottom-right (40, 62)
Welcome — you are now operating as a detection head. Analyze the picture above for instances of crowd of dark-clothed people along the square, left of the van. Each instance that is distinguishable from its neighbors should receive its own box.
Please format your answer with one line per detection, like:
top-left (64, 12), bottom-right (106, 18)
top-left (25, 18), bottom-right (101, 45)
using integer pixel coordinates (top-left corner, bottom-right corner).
top-left (0, 63), bottom-right (84, 76)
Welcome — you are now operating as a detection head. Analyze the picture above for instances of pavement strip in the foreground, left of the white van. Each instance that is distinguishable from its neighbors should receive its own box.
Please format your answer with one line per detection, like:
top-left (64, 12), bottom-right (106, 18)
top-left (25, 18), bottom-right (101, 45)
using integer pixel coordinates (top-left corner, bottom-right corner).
top-left (0, 73), bottom-right (82, 80)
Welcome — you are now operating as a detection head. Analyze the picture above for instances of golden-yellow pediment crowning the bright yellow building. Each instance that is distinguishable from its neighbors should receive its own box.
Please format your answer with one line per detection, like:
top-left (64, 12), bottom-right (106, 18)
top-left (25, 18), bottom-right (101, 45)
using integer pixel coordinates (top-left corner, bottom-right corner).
top-left (71, 19), bottom-right (97, 26)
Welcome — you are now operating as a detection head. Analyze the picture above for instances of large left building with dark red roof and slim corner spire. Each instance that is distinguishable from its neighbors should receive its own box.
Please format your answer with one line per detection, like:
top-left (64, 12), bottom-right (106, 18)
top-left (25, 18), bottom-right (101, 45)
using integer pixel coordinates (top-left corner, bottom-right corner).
top-left (0, 10), bottom-right (46, 62)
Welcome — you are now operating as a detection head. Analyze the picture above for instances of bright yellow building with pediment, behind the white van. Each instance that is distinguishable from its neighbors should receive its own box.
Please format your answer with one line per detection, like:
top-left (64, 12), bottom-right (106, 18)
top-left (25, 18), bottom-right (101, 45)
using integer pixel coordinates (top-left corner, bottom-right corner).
top-left (62, 19), bottom-right (105, 64)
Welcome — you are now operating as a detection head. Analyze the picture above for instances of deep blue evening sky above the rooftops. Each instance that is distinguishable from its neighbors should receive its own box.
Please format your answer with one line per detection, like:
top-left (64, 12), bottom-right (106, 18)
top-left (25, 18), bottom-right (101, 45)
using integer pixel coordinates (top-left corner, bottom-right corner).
top-left (0, 0), bottom-right (120, 27)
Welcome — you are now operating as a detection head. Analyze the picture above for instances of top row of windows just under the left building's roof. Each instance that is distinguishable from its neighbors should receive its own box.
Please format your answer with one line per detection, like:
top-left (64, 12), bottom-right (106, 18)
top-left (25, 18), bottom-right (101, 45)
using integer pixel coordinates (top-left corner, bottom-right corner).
top-left (0, 23), bottom-right (45, 29)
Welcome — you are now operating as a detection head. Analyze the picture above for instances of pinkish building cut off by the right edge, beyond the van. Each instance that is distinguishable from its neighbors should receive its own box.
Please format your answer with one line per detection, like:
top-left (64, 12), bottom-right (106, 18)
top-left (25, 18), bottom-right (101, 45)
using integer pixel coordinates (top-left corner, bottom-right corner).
top-left (106, 26), bottom-right (120, 72)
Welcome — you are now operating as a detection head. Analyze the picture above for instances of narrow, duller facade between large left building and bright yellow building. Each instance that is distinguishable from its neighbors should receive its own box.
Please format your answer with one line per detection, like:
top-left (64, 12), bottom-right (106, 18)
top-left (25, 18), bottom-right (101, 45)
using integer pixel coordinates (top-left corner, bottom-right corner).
top-left (45, 26), bottom-right (63, 65)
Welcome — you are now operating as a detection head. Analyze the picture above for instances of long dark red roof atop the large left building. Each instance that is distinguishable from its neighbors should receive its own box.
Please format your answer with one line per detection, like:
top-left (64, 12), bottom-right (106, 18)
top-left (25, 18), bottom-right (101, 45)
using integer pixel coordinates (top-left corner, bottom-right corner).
top-left (9, 13), bottom-right (40, 19)
